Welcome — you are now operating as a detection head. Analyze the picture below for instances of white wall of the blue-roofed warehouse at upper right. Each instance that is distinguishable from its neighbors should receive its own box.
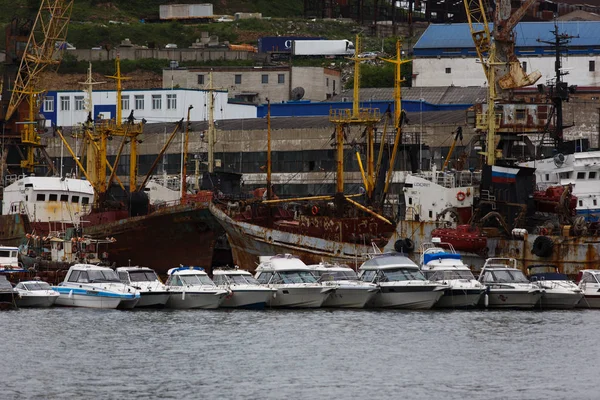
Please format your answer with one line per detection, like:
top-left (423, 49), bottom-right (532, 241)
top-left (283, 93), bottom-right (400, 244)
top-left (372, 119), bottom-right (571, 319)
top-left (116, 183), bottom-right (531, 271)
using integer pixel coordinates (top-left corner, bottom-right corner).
top-left (413, 55), bottom-right (600, 87)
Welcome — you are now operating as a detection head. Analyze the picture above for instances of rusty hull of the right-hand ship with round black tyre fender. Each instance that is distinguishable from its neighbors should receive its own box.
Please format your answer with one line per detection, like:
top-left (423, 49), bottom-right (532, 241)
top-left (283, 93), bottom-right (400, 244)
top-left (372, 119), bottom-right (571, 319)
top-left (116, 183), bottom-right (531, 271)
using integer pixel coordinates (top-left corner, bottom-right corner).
top-left (383, 221), bottom-right (600, 276)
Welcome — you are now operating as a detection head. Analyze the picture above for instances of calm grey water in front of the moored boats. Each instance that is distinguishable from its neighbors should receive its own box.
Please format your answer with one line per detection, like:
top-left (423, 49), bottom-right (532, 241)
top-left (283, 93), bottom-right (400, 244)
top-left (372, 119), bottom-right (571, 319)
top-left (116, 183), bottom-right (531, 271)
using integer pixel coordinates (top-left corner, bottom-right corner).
top-left (0, 308), bottom-right (600, 400)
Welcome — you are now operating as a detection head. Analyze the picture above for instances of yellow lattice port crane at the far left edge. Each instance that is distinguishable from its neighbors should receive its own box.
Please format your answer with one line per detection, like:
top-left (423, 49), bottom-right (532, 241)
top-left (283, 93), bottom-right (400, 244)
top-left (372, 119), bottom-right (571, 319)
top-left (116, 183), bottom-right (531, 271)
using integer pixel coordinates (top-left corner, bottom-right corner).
top-left (0, 0), bottom-right (73, 176)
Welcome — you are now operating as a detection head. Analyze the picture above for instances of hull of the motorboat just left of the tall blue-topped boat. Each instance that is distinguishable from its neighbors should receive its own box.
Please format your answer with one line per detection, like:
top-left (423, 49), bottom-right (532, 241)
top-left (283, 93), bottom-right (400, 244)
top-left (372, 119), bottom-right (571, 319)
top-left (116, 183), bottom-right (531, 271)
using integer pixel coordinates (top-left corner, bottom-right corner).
top-left (367, 286), bottom-right (444, 310)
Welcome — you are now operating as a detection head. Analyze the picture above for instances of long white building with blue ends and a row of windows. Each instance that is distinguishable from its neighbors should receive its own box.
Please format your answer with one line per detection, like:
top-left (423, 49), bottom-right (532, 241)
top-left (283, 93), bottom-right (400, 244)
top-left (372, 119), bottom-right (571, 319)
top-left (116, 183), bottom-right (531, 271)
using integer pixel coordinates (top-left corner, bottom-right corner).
top-left (41, 88), bottom-right (256, 126)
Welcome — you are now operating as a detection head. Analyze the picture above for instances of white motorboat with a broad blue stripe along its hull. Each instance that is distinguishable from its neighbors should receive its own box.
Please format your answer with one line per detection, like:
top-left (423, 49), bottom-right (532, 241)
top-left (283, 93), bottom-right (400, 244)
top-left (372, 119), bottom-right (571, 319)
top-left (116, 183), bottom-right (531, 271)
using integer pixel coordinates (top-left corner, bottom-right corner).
top-left (52, 264), bottom-right (140, 308)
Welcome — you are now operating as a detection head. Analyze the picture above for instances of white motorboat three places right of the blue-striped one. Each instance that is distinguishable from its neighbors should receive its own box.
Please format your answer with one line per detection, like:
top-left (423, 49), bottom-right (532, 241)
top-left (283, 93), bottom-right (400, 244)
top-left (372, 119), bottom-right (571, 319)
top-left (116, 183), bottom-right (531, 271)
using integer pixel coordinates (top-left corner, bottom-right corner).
top-left (213, 267), bottom-right (277, 309)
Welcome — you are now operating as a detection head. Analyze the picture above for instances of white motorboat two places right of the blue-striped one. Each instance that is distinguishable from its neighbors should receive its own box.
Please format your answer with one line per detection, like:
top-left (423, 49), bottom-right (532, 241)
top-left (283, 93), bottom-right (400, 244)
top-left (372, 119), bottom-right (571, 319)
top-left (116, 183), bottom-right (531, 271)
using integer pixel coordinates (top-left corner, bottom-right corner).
top-left (166, 266), bottom-right (230, 309)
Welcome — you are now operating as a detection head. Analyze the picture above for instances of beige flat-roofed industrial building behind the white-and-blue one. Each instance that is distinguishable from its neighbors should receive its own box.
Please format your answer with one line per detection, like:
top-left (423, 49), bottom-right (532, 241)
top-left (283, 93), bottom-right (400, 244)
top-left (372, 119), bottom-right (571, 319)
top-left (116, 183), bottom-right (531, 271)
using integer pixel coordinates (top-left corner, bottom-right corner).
top-left (163, 66), bottom-right (342, 104)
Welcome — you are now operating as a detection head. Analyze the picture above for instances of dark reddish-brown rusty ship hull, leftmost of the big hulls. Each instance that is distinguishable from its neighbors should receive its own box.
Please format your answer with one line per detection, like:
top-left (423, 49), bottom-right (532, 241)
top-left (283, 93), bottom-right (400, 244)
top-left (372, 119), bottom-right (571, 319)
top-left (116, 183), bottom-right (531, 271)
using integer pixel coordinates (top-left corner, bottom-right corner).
top-left (83, 202), bottom-right (221, 274)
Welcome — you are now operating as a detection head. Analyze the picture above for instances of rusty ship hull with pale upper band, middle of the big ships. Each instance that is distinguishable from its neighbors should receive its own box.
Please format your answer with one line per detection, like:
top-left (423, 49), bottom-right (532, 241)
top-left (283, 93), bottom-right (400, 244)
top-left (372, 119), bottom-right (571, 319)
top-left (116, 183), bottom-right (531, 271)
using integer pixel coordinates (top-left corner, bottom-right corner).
top-left (210, 204), bottom-right (382, 271)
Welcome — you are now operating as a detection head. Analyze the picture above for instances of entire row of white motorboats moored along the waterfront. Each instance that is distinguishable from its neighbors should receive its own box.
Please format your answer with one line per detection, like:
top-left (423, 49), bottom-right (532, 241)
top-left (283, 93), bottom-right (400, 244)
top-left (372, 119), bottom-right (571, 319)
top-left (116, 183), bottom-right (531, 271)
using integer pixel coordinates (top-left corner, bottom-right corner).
top-left (0, 240), bottom-right (600, 309)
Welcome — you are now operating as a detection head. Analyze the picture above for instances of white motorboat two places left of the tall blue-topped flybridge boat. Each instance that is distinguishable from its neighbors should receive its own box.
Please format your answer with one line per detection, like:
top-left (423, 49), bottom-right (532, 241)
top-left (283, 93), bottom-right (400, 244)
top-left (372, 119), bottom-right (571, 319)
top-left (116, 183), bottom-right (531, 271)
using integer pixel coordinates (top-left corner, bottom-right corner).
top-left (308, 262), bottom-right (379, 308)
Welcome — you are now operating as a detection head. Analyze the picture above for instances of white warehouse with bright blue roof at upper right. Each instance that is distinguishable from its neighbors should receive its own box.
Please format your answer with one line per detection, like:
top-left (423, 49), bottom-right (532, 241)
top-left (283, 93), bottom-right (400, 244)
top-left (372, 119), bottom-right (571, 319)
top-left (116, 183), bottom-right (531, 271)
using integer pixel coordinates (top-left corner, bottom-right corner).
top-left (412, 21), bottom-right (600, 87)
